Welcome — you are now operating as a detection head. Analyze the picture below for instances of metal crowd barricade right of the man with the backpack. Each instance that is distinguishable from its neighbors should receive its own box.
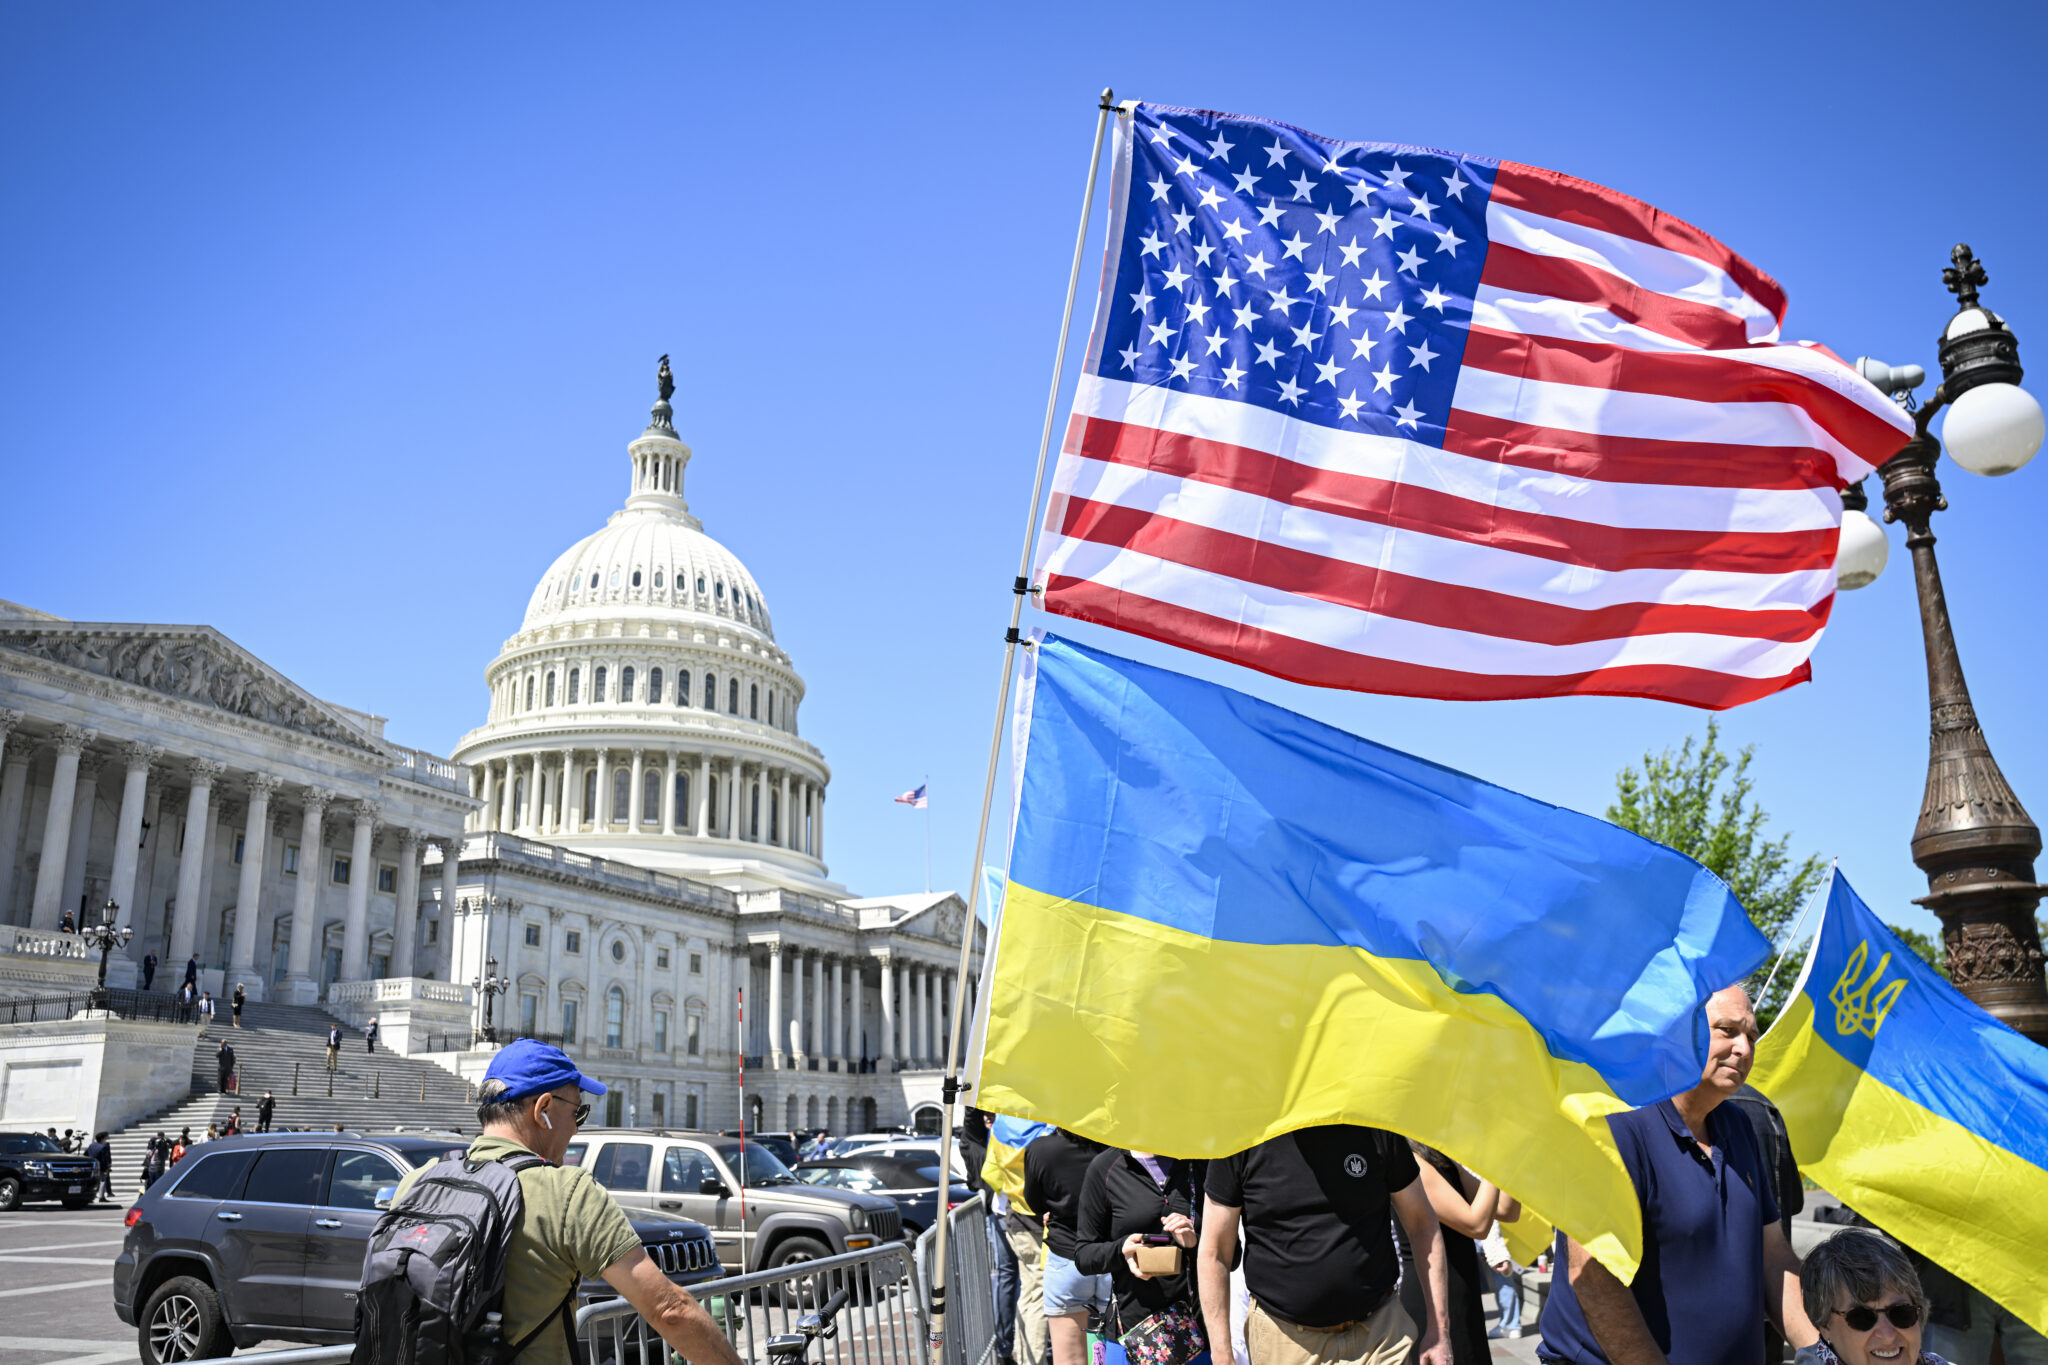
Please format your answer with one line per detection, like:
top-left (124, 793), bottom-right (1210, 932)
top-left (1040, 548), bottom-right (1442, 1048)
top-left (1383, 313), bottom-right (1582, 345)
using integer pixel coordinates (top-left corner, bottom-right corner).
top-left (575, 1242), bottom-right (928, 1365)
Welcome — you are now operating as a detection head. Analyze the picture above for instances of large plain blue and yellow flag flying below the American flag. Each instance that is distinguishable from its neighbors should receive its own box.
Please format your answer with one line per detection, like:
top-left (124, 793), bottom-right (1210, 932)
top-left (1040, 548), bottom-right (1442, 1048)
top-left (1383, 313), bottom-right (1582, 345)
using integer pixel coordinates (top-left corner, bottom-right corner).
top-left (975, 636), bottom-right (1767, 1277)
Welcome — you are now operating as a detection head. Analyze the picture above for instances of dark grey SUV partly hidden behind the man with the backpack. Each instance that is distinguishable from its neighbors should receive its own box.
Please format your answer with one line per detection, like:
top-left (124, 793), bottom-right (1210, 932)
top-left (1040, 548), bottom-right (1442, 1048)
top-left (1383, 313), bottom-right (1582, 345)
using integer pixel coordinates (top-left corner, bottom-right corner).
top-left (113, 1132), bottom-right (721, 1365)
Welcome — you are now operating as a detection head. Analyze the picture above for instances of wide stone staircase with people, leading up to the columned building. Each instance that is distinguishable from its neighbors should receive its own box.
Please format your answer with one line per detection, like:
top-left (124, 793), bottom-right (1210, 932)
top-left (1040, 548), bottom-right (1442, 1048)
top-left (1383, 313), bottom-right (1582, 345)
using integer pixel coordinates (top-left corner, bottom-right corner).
top-left (109, 1001), bottom-right (477, 1197)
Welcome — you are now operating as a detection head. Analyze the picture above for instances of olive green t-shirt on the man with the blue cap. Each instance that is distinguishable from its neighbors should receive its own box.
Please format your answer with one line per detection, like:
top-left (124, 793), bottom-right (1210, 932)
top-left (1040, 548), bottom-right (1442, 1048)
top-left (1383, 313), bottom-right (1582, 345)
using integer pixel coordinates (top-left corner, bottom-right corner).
top-left (397, 1138), bottom-right (641, 1365)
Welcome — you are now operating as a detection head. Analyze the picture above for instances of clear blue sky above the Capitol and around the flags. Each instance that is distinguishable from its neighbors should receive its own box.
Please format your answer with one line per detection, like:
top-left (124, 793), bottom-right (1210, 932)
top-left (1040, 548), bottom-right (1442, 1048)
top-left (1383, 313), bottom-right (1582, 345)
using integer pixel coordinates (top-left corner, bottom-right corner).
top-left (0, 0), bottom-right (2048, 957)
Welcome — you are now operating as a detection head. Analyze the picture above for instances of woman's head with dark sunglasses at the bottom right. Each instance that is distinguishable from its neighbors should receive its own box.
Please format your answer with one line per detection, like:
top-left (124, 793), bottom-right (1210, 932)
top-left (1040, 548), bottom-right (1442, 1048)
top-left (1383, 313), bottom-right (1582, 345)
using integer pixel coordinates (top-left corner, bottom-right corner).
top-left (1798, 1228), bottom-right (1948, 1365)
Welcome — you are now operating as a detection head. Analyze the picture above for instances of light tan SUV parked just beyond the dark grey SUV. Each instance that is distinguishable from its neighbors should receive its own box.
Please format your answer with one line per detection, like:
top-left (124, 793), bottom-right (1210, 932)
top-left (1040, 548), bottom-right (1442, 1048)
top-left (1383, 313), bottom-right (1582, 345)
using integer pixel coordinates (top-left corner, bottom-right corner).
top-left (563, 1128), bottom-right (903, 1273)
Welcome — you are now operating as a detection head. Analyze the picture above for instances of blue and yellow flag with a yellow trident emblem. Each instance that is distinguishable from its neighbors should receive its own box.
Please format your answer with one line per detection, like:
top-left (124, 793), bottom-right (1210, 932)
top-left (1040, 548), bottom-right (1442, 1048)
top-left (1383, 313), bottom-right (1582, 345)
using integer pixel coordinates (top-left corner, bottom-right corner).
top-left (1749, 872), bottom-right (2048, 1332)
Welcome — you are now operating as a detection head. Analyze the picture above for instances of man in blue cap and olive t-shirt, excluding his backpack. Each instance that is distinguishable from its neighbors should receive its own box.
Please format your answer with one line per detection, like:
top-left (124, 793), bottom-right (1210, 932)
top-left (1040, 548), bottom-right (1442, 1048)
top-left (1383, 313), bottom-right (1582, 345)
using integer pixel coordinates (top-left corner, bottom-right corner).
top-left (399, 1038), bottom-right (741, 1365)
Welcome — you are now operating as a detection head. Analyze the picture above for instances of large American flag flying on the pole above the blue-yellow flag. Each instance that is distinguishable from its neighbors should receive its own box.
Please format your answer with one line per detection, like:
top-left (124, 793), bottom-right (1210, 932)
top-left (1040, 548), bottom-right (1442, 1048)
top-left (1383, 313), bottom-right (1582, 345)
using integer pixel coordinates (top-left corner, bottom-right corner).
top-left (1036, 104), bottom-right (1911, 708)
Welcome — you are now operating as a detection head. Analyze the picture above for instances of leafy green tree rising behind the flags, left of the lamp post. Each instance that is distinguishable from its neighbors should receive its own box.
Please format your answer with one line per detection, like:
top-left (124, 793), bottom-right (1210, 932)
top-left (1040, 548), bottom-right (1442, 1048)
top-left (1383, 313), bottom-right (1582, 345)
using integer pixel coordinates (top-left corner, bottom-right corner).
top-left (1608, 720), bottom-right (1827, 1027)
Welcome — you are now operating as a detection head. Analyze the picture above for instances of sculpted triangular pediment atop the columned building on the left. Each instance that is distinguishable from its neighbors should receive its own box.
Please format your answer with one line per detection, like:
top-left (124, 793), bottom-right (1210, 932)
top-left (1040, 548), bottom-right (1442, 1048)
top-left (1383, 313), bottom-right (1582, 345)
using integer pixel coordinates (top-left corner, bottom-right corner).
top-left (0, 624), bottom-right (371, 749)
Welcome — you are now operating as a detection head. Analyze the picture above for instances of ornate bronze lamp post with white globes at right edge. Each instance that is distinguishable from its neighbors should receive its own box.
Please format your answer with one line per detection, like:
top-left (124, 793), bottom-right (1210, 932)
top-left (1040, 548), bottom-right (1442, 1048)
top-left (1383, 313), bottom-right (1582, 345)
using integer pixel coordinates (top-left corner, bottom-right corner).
top-left (1839, 246), bottom-right (2048, 1044)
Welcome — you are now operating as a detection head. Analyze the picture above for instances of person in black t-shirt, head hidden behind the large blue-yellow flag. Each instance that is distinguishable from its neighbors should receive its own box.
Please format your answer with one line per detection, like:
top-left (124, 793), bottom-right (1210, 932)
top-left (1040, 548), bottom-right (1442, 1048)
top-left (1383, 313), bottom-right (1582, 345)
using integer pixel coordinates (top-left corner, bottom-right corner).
top-left (1196, 1124), bottom-right (1450, 1365)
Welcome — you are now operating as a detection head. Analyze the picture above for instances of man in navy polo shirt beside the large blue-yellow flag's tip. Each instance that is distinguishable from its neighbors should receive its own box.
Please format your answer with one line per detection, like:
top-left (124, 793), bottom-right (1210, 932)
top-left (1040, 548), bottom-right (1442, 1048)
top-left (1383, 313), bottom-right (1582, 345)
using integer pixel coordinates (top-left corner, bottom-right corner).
top-left (1536, 986), bottom-right (1819, 1365)
